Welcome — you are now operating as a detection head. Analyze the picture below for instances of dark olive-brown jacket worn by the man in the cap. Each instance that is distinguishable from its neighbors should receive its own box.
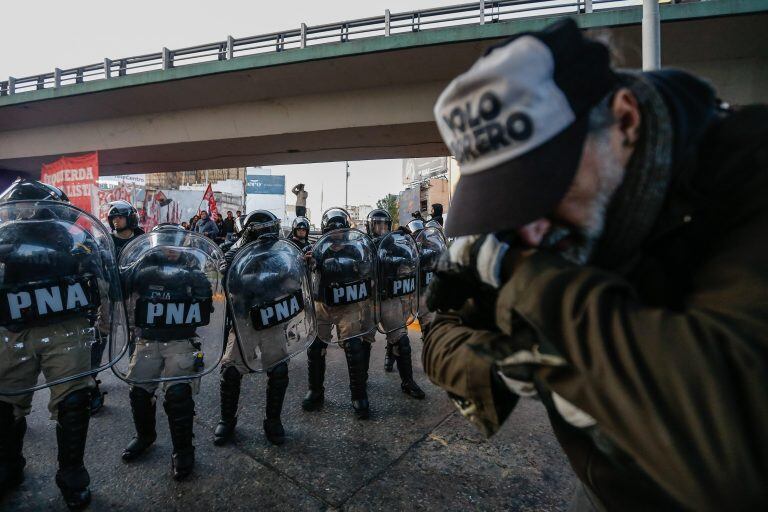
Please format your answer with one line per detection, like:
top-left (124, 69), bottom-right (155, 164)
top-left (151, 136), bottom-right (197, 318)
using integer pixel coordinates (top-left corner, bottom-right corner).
top-left (423, 71), bottom-right (768, 510)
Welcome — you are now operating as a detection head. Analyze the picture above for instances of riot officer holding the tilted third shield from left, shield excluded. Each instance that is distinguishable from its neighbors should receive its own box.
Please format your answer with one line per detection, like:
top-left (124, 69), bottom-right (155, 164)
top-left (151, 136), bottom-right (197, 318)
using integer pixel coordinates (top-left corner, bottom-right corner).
top-left (213, 210), bottom-right (289, 446)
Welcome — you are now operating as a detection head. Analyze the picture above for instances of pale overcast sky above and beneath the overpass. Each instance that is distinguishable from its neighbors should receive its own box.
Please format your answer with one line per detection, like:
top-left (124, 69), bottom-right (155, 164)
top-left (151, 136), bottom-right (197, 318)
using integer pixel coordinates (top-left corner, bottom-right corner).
top-left (0, 0), bottom-right (450, 212)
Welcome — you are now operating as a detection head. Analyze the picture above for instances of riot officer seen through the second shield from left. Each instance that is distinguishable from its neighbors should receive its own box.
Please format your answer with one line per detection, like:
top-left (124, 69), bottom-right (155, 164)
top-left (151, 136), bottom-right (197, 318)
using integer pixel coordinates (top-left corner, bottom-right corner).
top-left (122, 225), bottom-right (213, 480)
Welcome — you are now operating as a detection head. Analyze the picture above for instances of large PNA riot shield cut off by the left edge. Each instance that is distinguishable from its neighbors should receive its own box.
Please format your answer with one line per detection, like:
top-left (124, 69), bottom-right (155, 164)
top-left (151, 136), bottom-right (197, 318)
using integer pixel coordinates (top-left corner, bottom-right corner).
top-left (0, 200), bottom-right (127, 395)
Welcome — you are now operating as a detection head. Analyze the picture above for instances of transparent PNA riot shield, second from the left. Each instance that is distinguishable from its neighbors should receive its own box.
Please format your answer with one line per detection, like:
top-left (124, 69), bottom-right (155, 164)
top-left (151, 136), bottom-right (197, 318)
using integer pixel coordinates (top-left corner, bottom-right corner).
top-left (112, 229), bottom-right (226, 386)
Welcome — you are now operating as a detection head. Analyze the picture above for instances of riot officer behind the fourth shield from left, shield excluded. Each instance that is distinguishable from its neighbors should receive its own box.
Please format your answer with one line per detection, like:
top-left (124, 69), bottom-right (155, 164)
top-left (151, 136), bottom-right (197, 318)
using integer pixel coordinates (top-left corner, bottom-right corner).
top-left (302, 207), bottom-right (375, 419)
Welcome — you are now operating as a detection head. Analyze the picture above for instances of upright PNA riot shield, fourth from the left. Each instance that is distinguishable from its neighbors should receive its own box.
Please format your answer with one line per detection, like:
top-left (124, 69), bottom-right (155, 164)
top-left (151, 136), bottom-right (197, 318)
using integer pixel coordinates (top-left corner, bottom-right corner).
top-left (310, 229), bottom-right (376, 342)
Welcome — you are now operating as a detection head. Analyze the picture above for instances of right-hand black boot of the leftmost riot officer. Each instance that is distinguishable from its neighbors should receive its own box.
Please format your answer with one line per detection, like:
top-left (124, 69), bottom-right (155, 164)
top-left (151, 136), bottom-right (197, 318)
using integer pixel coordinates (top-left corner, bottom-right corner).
top-left (56, 388), bottom-right (91, 510)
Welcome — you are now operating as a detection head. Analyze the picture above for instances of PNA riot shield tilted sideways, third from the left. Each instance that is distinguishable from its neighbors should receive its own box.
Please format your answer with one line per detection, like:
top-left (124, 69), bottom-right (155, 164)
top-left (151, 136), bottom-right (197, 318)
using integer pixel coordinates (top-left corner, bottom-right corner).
top-left (226, 237), bottom-right (316, 372)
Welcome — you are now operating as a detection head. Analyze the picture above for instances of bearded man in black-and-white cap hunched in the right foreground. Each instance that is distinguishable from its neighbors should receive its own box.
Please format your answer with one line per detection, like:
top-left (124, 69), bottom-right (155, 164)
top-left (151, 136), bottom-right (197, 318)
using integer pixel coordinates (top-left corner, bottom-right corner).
top-left (422, 20), bottom-right (768, 511)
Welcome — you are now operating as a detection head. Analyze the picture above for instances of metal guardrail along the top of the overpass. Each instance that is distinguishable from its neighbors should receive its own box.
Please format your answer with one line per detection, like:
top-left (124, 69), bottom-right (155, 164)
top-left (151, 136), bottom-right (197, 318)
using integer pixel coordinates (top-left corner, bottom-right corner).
top-left (0, 0), bottom-right (678, 96)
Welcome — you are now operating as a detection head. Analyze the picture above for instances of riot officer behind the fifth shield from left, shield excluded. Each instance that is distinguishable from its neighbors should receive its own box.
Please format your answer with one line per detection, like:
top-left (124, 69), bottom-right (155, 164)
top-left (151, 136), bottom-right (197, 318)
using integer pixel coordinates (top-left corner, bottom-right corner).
top-left (363, 209), bottom-right (425, 399)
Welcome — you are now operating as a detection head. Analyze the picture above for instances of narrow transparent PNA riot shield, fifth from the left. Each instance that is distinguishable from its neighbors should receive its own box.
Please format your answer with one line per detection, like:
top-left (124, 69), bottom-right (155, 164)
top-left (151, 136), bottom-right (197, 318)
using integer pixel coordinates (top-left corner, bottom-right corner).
top-left (376, 231), bottom-right (419, 334)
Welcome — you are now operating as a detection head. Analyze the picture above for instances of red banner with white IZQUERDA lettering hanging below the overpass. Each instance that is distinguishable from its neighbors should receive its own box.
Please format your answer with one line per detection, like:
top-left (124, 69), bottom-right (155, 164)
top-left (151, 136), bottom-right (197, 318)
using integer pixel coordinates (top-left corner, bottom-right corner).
top-left (40, 152), bottom-right (99, 214)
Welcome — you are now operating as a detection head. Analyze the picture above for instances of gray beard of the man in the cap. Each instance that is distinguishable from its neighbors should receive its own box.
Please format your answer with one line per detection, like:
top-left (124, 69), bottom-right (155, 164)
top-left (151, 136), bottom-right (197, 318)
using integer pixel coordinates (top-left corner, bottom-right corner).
top-left (540, 130), bottom-right (624, 265)
